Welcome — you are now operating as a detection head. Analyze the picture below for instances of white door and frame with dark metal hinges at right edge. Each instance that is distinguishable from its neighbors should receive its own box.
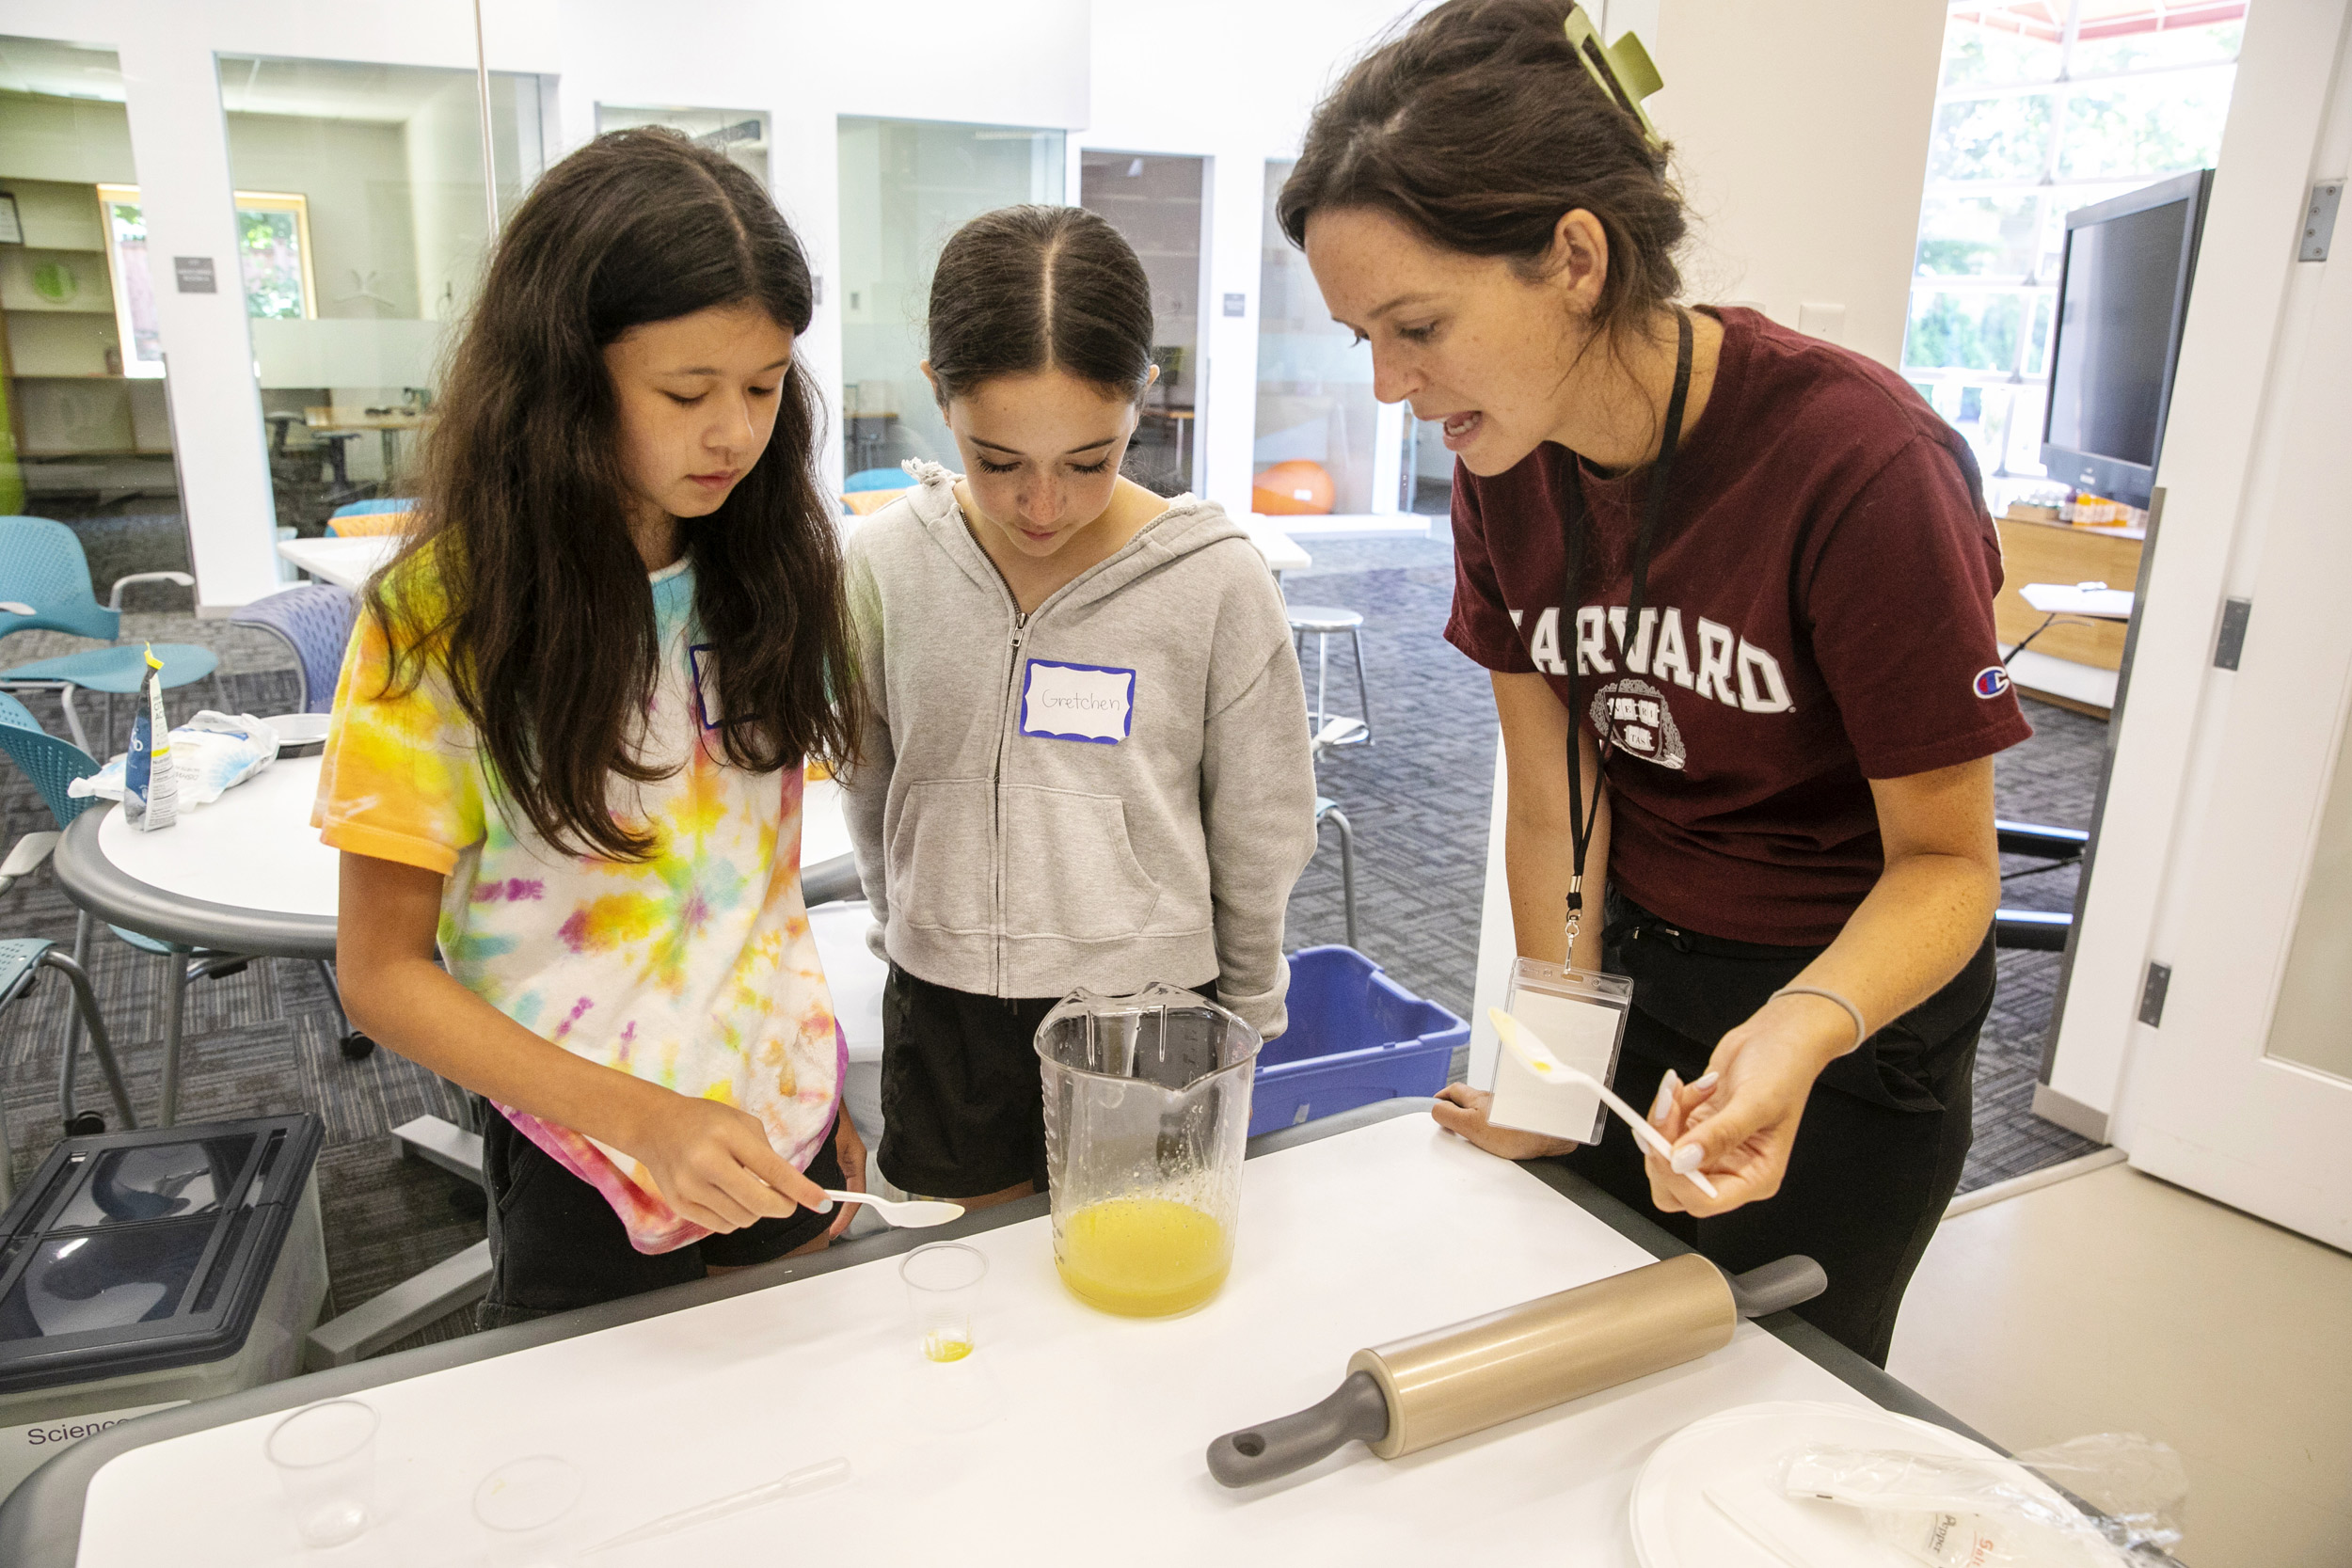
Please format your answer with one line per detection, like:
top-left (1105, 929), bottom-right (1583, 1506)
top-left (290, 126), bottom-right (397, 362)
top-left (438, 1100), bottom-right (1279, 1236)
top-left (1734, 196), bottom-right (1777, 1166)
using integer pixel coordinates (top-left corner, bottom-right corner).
top-left (2054, 0), bottom-right (2352, 1246)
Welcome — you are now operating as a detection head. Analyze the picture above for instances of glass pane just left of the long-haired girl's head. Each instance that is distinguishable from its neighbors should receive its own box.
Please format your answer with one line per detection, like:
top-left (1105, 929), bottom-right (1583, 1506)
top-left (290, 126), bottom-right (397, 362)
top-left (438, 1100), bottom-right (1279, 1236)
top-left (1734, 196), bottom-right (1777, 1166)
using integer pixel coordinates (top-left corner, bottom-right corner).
top-left (219, 54), bottom-right (541, 536)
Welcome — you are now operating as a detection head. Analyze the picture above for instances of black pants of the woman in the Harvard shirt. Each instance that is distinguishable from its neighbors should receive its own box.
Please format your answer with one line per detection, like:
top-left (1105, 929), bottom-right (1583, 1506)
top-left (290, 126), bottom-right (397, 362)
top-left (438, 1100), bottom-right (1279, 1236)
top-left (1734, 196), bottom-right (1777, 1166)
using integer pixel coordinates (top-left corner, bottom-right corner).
top-left (1566, 894), bottom-right (1994, 1366)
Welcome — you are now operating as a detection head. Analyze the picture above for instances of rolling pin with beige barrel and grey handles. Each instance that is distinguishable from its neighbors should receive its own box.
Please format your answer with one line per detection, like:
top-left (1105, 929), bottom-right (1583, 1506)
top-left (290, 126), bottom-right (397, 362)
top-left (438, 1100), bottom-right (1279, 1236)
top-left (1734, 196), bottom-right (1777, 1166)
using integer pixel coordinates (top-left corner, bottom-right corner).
top-left (1209, 1253), bottom-right (1830, 1486)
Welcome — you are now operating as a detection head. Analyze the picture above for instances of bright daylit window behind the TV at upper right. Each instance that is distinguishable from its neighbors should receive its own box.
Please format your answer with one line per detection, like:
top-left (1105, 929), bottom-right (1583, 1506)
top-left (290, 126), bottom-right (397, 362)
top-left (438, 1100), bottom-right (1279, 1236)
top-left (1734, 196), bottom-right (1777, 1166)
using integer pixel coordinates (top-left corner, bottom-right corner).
top-left (1903, 0), bottom-right (2247, 510)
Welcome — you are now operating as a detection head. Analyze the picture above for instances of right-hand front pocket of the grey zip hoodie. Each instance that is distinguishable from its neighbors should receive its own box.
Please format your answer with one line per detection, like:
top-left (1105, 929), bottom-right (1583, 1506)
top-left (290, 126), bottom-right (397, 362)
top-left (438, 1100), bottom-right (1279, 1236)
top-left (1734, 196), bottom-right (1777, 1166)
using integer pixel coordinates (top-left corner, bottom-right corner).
top-left (1005, 785), bottom-right (1160, 942)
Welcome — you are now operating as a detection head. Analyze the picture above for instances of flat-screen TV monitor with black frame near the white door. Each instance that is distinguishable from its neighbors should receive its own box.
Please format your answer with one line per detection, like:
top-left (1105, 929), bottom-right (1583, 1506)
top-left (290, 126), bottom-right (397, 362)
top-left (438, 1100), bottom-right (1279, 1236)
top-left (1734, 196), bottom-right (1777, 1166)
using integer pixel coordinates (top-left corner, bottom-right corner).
top-left (2042, 169), bottom-right (2214, 505)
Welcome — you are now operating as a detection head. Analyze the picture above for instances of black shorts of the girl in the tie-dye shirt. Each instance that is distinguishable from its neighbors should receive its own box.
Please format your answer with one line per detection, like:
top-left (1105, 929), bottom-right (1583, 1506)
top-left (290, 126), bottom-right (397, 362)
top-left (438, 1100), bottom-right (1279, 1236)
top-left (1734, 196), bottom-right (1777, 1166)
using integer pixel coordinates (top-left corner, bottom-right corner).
top-left (480, 1102), bottom-right (842, 1328)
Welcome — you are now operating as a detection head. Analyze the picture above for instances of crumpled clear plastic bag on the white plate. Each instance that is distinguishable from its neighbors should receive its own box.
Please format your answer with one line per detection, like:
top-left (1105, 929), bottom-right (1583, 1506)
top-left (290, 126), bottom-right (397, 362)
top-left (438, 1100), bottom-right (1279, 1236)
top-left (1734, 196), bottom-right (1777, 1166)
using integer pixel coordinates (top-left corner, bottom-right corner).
top-left (1781, 1432), bottom-right (2187, 1568)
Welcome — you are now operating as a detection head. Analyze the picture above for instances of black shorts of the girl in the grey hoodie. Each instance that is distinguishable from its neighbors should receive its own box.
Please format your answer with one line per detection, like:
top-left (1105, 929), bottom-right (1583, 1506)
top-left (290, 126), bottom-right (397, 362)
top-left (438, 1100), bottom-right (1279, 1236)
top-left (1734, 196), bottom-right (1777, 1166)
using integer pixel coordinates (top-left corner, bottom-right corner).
top-left (875, 964), bottom-right (1216, 1199)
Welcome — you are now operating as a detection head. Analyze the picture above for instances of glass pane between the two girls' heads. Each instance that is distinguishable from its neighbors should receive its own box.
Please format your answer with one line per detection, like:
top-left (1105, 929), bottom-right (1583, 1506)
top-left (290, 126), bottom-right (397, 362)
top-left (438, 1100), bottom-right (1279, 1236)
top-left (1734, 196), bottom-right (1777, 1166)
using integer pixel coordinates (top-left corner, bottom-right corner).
top-left (840, 115), bottom-right (1066, 479)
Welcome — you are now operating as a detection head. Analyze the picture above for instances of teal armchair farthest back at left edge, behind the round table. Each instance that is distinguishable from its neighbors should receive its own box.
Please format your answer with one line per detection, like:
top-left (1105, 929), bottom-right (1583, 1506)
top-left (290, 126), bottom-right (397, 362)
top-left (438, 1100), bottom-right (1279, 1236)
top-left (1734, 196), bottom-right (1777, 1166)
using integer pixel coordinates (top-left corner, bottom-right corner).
top-left (0, 517), bottom-right (221, 752)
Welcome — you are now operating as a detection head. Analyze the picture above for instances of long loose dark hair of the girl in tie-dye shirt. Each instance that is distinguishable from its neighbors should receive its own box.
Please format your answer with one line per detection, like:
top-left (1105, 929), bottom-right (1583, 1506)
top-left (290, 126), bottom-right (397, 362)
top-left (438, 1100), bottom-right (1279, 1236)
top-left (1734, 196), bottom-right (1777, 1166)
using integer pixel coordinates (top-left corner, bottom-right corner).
top-left (367, 129), bottom-right (859, 861)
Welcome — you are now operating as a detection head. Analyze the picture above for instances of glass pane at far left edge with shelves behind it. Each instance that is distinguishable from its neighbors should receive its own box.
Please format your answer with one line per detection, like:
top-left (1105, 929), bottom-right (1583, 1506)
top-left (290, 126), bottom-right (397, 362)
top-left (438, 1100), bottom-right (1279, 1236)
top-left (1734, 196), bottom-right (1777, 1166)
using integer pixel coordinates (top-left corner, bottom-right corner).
top-left (0, 38), bottom-right (188, 599)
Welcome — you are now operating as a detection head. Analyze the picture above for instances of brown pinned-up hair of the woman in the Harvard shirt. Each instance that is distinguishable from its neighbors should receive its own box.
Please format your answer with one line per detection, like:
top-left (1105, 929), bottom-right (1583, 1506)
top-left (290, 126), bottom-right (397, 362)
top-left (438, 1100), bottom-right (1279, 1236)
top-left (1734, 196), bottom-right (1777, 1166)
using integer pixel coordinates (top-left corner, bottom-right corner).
top-left (1275, 0), bottom-right (1687, 341)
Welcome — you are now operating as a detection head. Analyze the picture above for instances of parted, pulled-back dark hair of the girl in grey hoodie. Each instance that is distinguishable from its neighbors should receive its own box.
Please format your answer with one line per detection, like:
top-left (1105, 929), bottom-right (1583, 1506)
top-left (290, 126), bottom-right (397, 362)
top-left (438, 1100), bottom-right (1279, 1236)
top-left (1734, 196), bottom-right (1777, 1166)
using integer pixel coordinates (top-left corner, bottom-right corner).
top-left (930, 207), bottom-right (1152, 402)
